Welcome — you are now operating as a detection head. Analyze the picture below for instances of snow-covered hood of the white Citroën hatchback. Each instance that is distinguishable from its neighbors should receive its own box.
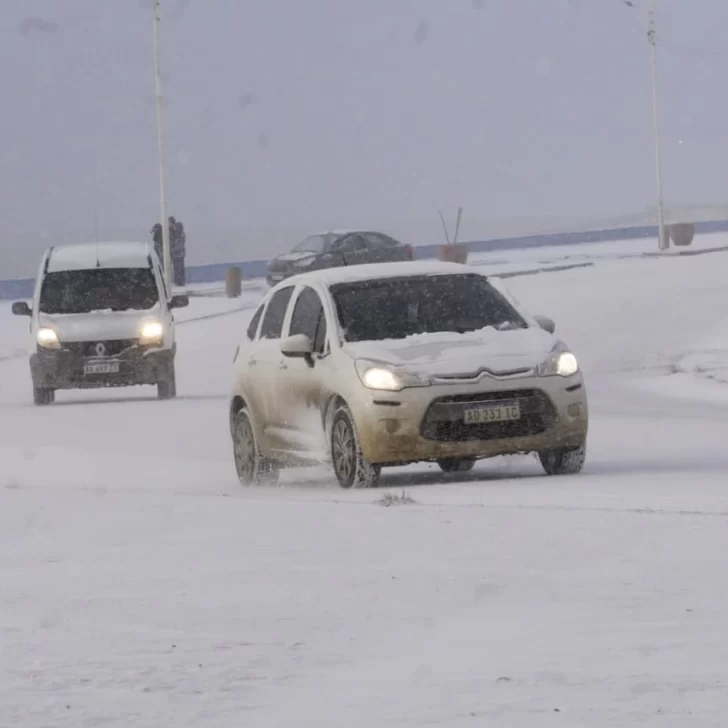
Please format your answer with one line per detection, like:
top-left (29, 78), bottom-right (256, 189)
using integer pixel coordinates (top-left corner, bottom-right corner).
top-left (344, 327), bottom-right (557, 377)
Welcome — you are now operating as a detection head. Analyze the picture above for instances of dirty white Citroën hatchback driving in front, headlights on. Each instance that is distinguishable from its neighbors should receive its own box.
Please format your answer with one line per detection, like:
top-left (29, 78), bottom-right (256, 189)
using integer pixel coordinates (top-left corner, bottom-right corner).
top-left (230, 261), bottom-right (588, 488)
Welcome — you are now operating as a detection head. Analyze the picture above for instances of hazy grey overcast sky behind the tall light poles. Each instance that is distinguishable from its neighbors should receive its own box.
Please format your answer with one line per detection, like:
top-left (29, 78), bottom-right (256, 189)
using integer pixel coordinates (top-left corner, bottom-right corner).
top-left (0, 0), bottom-right (728, 278)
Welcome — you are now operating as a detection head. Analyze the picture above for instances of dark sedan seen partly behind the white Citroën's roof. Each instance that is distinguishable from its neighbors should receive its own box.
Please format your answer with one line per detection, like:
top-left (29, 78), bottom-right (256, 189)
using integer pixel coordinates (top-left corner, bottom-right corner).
top-left (266, 230), bottom-right (414, 286)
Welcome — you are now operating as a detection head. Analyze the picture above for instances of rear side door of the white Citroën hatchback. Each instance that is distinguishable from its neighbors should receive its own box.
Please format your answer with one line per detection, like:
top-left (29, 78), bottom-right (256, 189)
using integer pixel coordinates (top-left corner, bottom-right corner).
top-left (245, 286), bottom-right (294, 451)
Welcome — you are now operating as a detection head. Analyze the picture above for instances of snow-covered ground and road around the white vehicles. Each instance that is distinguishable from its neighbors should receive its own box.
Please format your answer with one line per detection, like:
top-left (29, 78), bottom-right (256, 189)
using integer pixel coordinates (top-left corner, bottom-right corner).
top-left (0, 237), bottom-right (728, 728)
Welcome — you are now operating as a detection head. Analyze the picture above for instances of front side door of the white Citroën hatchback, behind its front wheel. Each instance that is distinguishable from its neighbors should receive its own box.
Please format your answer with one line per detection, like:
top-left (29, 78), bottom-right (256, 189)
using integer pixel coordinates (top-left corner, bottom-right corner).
top-left (276, 285), bottom-right (331, 457)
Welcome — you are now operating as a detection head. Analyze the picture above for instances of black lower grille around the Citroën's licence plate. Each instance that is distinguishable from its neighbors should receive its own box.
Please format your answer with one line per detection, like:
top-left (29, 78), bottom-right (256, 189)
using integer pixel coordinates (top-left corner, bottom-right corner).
top-left (420, 389), bottom-right (558, 442)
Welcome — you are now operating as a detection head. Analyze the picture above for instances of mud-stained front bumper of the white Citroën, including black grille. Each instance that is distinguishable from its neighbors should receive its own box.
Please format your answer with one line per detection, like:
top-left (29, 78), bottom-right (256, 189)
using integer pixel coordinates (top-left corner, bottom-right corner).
top-left (352, 374), bottom-right (589, 465)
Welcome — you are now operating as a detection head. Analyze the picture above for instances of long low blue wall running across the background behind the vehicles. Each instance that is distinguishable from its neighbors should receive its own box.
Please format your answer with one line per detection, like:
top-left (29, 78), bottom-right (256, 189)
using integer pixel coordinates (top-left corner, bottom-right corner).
top-left (5, 220), bottom-right (728, 300)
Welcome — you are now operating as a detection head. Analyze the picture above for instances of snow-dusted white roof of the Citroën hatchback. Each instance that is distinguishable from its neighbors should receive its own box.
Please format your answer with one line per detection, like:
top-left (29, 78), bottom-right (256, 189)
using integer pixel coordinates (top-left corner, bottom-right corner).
top-left (276, 260), bottom-right (472, 288)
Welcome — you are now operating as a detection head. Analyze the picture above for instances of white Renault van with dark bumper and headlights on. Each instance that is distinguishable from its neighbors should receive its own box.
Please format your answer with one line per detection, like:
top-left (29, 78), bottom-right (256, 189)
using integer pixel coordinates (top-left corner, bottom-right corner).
top-left (13, 242), bottom-right (189, 405)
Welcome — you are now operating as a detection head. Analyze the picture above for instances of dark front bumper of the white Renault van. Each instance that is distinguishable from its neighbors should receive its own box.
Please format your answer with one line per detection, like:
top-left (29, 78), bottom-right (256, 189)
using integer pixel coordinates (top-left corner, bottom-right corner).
top-left (30, 346), bottom-right (175, 389)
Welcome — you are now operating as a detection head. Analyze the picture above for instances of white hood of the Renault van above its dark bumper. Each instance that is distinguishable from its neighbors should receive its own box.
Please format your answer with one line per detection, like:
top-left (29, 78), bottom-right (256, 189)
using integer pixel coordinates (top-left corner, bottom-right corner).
top-left (38, 305), bottom-right (159, 341)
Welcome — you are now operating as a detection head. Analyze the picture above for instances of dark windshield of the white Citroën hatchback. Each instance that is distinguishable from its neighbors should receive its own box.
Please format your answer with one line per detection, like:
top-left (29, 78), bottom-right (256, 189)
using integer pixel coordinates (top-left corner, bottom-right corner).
top-left (331, 274), bottom-right (528, 342)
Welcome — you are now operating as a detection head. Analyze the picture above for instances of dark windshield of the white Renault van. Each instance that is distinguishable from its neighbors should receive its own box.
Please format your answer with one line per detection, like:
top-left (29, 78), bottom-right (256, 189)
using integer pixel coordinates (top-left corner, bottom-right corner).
top-left (39, 268), bottom-right (159, 314)
